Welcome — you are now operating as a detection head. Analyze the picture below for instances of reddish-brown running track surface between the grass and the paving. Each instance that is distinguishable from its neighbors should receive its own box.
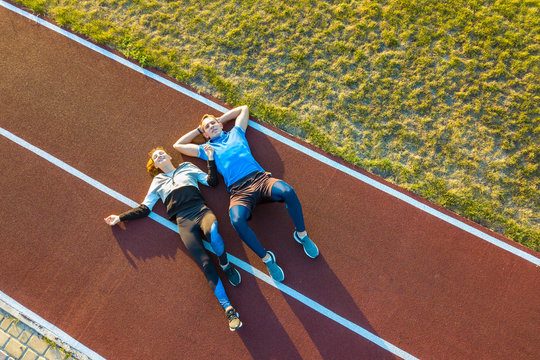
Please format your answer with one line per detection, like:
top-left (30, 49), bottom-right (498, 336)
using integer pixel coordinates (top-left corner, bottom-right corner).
top-left (0, 4), bottom-right (540, 359)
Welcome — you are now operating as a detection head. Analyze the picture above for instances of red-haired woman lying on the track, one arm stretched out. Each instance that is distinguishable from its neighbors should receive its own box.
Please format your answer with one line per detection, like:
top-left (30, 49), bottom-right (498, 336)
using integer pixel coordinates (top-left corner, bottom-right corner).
top-left (105, 146), bottom-right (242, 331)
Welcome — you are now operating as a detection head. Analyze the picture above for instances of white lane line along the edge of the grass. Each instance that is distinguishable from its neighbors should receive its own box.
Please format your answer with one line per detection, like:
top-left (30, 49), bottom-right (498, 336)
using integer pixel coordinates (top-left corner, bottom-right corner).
top-left (0, 0), bottom-right (540, 266)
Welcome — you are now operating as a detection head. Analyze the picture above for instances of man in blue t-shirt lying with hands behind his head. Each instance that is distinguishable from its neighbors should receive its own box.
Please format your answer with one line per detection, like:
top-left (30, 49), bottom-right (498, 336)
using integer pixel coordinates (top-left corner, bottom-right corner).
top-left (174, 105), bottom-right (319, 281)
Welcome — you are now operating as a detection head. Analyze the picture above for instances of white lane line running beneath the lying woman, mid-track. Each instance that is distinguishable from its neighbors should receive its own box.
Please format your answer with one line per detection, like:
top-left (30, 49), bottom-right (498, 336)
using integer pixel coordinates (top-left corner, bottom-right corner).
top-left (0, 127), bottom-right (416, 360)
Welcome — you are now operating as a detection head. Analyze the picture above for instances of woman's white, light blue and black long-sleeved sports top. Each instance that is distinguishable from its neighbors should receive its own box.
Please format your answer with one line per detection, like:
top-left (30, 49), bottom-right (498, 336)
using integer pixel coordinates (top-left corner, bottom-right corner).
top-left (120, 160), bottom-right (218, 221)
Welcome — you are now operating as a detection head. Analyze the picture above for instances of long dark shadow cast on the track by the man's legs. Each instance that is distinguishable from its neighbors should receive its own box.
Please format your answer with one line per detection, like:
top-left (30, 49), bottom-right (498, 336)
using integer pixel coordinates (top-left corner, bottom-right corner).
top-left (250, 203), bottom-right (396, 359)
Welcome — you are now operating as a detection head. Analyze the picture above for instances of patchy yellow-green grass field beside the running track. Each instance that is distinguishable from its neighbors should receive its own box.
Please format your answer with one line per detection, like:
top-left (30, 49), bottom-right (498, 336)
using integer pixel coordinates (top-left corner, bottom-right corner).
top-left (13, 0), bottom-right (540, 251)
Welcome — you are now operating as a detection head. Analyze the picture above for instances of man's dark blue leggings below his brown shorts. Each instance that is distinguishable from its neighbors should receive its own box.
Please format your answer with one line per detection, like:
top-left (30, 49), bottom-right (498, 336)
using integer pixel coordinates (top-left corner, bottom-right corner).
top-left (229, 181), bottom-right (306, 259)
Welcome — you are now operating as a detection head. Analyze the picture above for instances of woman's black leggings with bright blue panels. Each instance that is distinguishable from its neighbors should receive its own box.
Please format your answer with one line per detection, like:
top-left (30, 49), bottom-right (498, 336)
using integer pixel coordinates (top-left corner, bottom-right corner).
top-left (176, 210), bottom-right (231, 309)
